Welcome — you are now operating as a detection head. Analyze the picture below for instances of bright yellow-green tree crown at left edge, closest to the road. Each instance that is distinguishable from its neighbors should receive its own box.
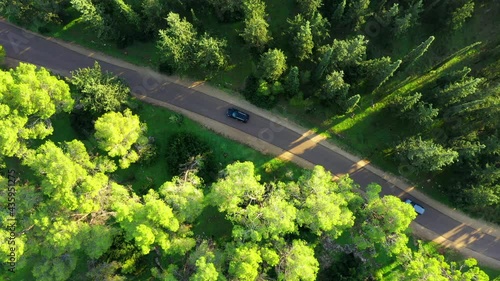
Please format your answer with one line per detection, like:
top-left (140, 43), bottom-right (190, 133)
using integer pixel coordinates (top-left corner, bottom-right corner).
top-left (0, 63), bottom-right (74, 158)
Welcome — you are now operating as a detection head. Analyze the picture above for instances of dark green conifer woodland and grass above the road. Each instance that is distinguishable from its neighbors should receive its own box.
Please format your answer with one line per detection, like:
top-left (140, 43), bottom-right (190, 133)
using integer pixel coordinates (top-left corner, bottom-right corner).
top-left (0, 0), bottom-right (500, 223)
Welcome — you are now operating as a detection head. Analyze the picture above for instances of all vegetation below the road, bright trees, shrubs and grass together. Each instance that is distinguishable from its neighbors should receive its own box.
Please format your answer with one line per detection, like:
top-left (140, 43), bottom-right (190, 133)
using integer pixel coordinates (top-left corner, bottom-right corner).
top-left (0, 60), bottom-right (496, 281)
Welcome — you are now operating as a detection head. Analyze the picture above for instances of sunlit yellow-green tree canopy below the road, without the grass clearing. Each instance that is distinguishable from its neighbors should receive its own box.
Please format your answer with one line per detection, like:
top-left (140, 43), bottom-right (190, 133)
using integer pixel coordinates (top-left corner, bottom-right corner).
top-left (0, 61), bottom-right (488, 280)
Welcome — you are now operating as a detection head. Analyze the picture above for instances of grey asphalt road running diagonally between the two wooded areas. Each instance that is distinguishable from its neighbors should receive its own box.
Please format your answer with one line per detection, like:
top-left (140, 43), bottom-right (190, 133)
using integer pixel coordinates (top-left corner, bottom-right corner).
top-left (0, 19), bottom-right (500, 268)
